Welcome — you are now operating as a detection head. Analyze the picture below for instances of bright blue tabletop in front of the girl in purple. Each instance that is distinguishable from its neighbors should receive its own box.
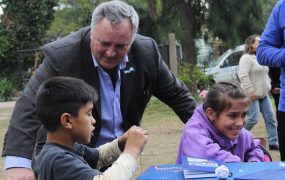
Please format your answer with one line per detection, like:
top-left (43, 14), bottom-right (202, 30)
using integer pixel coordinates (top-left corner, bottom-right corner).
top-left (137, 162), bottom-right (285, 180)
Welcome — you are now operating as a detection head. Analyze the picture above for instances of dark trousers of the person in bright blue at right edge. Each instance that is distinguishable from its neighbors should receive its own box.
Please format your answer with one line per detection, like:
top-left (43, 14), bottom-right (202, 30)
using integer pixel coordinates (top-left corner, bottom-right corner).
top-left (277, 111), bottom-right (285, 161)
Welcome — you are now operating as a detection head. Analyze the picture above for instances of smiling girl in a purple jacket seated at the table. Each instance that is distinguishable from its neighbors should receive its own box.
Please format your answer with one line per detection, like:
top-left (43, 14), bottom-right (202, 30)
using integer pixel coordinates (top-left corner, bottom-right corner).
top-left (176, 82), bottom-right (265, 164)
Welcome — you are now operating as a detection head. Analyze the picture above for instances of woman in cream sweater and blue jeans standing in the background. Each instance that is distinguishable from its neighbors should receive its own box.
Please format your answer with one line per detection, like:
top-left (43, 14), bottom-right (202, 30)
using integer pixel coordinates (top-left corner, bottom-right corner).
top-left (238, 34), bottom-right (279, 150)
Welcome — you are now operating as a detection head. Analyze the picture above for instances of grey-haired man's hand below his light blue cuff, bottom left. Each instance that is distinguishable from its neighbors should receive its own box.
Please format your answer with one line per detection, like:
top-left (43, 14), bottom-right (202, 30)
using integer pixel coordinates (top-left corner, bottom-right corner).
top-left (4, 168), bottom-right (35, 180)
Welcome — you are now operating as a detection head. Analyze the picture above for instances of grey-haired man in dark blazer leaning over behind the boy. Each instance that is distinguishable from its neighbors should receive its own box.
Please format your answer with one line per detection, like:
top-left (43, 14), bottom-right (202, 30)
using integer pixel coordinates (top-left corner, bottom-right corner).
top-left (2, 1), bottom-right (196, 179)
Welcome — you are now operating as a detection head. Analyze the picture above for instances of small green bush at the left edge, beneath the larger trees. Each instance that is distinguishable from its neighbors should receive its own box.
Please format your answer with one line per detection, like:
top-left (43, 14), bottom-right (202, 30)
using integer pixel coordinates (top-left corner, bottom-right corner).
top-left (0, 78), bottom-right (15, 101)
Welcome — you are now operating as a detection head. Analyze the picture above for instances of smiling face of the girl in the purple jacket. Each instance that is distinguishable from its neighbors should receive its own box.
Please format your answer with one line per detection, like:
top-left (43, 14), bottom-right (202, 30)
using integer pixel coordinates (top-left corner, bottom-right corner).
top-left (206, 99), bottom-right (249, 139)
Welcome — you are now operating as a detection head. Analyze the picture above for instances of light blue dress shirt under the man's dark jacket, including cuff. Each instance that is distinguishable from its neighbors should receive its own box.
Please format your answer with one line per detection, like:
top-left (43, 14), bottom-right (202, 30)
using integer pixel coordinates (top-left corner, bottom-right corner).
top-left (4, 55), bottom-right (128, 169)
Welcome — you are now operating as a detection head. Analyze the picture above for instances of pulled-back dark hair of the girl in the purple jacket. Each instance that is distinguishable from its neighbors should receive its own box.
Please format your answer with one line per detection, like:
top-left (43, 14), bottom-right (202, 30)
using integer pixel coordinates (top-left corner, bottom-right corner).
top-left (203, 82), bottom-right (249, 116)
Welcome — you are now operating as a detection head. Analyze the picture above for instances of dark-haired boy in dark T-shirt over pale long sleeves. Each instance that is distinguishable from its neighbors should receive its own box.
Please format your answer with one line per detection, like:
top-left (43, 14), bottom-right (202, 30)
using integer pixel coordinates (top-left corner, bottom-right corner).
top-left (33, 77), bottom-right (147, 180)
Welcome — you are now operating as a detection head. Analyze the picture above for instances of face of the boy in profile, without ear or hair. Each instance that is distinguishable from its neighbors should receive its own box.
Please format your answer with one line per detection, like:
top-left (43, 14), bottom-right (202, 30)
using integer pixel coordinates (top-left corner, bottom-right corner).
top-left (71, 102), bottom-right (96, 144)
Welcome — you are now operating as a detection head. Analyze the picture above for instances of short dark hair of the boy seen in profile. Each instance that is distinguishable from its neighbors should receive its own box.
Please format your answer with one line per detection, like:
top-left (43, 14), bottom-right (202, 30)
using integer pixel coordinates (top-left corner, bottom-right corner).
top-left (36, 77), bottom-right (98, 132)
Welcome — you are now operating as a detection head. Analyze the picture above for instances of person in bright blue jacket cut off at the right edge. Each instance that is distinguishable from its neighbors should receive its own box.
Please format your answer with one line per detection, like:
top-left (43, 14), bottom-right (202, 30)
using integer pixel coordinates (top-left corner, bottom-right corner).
top-left (257, 0), bottom-right (285, 161)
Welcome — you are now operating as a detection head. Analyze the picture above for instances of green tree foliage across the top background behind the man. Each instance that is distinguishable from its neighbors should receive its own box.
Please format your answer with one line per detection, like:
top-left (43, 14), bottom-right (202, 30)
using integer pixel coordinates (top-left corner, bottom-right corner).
top-left (0, 0), bottom-right (277, 100)
